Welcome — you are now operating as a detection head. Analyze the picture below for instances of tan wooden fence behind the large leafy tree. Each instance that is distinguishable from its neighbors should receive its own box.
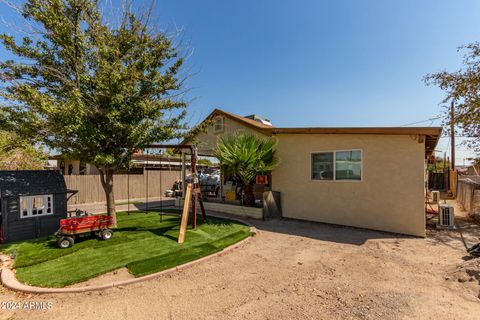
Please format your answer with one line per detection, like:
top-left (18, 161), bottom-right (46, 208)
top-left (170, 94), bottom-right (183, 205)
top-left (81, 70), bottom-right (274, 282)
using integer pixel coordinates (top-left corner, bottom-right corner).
top-left (65, 170), bottom-right (181, 204)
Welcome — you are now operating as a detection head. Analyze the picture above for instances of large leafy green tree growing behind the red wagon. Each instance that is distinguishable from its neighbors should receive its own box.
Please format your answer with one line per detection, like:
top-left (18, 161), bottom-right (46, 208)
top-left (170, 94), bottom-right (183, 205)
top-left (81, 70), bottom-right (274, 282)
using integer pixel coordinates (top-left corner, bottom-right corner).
top-left (0, 0), bottom-right (186, 224)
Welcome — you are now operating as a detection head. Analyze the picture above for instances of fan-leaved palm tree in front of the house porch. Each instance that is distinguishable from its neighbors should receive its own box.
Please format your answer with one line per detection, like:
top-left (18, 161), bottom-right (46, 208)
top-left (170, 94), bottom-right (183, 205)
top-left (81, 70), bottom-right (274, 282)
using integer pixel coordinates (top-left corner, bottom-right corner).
top-left (215, 133), bottom-right (279, 205)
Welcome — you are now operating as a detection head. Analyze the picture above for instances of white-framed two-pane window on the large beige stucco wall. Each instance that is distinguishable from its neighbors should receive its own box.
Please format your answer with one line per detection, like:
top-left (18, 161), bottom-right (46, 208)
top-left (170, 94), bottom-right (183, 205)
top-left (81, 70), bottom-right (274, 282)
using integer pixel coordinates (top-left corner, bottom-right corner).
top-left (312, 150), bottom-right (362, 181)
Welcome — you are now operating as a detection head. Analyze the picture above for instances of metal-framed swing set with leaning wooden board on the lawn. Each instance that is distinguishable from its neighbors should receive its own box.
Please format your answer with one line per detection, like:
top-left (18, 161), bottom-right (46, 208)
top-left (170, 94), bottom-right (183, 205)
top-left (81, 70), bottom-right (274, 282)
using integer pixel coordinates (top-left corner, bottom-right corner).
top-left (127, 144), bottom-right (207, 244)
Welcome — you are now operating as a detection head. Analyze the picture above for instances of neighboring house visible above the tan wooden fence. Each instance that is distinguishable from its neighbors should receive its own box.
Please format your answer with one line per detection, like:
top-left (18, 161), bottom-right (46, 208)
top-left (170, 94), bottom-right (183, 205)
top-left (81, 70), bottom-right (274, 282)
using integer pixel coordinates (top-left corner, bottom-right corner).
top-left (49, 153), bottom-right (203, 175)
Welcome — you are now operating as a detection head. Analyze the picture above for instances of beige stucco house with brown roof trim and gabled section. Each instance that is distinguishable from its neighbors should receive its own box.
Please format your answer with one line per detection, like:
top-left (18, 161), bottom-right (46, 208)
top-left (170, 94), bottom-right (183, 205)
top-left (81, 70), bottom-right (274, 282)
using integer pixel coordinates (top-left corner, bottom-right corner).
top-left (184, 109), bottom-right (442, 236)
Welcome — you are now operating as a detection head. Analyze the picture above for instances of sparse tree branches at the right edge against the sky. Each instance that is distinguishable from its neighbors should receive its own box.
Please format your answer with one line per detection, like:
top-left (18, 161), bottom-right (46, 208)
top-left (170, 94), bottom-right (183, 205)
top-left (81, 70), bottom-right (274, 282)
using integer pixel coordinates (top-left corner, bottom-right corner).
top-left (424, 42), bottom-right (480, 153)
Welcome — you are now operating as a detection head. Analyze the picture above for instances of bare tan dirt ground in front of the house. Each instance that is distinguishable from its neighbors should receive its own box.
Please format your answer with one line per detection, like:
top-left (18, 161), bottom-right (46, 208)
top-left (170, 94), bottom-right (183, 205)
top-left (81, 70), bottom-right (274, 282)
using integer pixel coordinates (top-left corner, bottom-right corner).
top-left (0, 205), bottom-right (480, 319)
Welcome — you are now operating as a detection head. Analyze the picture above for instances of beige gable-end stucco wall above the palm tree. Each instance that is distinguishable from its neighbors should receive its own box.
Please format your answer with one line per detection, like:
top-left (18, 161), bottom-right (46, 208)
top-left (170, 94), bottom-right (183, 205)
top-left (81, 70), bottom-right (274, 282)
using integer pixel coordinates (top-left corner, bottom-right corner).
top-left (194, 118), bottom-right (268, 155)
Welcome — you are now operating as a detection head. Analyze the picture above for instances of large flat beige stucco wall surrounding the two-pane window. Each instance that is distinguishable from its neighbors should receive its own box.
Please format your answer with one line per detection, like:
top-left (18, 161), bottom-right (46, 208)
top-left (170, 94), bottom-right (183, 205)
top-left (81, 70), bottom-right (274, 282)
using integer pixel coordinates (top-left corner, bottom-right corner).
top-left (272, 134), bottom-right (425, 236)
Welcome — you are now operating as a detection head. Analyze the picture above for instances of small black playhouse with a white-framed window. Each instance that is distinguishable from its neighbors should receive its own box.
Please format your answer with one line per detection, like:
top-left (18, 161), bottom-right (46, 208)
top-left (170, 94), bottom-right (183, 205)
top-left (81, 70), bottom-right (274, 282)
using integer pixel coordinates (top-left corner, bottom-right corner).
top-left (0, 170), bottom-right (74, 243)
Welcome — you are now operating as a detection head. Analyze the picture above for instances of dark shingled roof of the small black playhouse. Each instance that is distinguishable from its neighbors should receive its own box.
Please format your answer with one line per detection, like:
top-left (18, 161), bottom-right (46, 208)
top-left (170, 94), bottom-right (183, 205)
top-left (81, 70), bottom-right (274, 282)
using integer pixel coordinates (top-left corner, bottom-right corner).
top-left (0, 170), bottom-right (68, 197)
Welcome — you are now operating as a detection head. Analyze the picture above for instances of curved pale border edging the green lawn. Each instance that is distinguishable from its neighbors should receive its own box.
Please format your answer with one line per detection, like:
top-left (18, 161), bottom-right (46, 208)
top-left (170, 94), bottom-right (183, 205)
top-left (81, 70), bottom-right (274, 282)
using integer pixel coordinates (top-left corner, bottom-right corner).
top-left (0, 214), bottom-right (258, 294)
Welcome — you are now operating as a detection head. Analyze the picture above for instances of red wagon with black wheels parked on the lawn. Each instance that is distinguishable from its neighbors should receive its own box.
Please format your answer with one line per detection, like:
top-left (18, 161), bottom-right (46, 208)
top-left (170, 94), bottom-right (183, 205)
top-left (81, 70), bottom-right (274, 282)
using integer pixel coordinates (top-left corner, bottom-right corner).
top-left (55, 211), bottom-right (113, 249)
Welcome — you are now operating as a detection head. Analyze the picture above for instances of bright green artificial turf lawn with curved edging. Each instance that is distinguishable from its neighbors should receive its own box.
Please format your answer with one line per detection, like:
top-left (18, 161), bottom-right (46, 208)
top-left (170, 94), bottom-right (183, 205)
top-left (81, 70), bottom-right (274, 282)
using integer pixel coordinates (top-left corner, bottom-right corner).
top-left (0, 210), bottom-right (250, 287)
